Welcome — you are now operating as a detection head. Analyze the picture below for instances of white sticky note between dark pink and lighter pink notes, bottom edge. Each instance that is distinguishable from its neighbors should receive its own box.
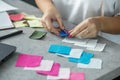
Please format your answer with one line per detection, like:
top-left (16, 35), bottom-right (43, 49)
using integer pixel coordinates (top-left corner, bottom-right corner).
top-left (47, 68), bottom-right (70, 80)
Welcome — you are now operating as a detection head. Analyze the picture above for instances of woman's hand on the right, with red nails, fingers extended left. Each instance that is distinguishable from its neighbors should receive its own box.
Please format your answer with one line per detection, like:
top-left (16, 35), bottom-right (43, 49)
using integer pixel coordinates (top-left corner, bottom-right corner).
top-left (70, 18), bottom-right (101, 38)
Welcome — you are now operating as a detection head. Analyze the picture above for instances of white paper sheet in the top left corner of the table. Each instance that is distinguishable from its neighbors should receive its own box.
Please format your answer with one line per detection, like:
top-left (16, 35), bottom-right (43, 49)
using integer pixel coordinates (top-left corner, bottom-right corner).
top-left (0, 0), bottom-right (17, 12)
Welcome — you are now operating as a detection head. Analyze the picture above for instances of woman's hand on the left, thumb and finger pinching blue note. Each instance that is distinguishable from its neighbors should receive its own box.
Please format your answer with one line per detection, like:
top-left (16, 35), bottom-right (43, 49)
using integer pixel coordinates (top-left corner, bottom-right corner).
top-left (41, 8), bottom-right (64, 35)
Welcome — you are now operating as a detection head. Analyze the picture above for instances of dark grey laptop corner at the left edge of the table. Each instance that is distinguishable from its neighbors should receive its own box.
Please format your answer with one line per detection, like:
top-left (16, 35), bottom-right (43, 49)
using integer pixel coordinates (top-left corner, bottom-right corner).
top-left (0, 43), bottom-right (16, 62)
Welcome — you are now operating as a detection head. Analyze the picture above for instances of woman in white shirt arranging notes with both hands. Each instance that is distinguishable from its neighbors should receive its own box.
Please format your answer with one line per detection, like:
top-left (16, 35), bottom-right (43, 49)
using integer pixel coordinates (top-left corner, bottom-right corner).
top-left (35, 0), bottom-right (120, 44)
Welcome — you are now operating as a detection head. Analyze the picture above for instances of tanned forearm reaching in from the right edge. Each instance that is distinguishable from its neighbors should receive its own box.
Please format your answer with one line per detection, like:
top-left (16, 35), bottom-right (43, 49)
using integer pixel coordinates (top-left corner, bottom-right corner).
top-left (95, 16), bottom-right (120, 34)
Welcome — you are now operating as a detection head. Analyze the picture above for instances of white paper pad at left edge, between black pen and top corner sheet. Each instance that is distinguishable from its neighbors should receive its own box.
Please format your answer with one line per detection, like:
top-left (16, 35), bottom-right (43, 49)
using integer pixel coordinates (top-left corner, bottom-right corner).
top-left (0, 12), bottom-right (14, 30)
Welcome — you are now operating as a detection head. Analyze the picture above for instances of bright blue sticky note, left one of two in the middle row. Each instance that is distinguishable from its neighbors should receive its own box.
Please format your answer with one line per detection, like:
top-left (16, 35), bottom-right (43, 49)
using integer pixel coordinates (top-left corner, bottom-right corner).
top-left (48, 44), bottom-right (71, 55)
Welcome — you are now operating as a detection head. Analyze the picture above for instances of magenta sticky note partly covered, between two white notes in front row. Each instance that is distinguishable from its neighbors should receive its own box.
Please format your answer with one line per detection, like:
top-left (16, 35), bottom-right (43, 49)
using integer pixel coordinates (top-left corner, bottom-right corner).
top-left (36, 63), bottom-right (60, 76)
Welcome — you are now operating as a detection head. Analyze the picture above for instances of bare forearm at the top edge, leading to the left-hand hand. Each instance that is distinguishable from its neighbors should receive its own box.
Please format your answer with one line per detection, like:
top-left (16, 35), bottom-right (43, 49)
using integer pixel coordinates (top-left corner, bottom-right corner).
top-left (35, 0), bottom-right (55, 13)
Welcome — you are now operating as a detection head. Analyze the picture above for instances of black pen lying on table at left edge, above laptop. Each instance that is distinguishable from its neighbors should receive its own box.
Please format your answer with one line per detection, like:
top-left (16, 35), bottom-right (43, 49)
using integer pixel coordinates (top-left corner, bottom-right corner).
top-left (0, 30), bottom-right (23, 40)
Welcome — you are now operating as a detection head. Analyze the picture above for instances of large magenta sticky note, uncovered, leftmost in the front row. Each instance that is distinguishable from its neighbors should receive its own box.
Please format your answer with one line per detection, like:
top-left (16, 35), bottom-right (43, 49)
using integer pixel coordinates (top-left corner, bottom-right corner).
top-left (16, 54), bottom-right (43, 67)
